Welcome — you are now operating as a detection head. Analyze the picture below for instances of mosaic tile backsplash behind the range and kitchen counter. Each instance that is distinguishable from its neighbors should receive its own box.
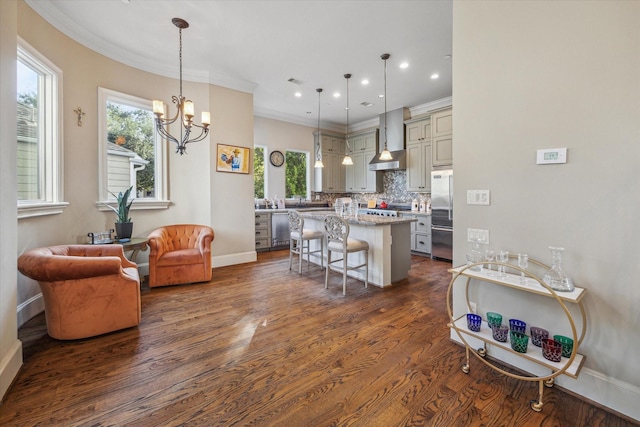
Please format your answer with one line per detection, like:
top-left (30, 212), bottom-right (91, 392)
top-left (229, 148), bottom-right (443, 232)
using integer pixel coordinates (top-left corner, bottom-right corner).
top-left (311, 170), bottom-right (430, 203)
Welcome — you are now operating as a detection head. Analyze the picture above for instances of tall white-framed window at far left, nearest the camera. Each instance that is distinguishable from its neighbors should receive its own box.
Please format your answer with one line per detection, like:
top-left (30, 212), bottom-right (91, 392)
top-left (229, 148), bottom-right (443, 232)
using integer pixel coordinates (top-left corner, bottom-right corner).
top-left (16, 38), bottom-right (68, 218)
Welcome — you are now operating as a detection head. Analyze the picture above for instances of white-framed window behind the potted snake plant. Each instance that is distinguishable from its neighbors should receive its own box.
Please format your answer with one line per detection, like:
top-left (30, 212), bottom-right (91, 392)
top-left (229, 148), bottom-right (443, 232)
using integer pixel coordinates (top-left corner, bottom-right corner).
top-left (98, 88), bottom-right (168, 209)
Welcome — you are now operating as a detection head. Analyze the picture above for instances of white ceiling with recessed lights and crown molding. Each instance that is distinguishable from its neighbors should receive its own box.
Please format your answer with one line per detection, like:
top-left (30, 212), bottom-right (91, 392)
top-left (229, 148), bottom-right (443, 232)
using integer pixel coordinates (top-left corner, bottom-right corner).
top-left (26, 0), bottom-right (453, 127)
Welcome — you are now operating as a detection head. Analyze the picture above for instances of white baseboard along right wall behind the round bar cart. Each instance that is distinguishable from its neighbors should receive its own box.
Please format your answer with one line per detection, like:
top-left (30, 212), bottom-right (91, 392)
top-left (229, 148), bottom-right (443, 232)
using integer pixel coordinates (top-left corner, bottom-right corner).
top-left (450, 330), bottom-right (640, 421)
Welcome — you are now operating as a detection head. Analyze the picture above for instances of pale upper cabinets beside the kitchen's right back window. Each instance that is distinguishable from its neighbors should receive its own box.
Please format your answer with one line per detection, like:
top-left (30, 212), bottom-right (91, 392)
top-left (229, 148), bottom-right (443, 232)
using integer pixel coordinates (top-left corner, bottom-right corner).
top-left (312, 132), bottom-right (345, 193)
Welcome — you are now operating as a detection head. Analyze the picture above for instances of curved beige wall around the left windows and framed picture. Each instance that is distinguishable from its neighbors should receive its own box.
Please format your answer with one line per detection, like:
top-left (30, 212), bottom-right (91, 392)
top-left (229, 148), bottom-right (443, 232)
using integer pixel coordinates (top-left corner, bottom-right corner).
top-left (14, 2), bottom-right (255, 319)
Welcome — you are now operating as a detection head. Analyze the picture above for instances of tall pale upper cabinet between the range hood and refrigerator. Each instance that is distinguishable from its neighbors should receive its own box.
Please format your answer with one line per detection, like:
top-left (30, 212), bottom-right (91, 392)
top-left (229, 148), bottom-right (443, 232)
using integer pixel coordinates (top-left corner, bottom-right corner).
top-left (405, 117), bottom-right (432, 193)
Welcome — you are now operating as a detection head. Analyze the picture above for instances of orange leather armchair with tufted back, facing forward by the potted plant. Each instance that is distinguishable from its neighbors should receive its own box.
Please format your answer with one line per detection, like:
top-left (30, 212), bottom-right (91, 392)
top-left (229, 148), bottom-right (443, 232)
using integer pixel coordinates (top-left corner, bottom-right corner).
top-left (149, 224), bottom-right (214, 288)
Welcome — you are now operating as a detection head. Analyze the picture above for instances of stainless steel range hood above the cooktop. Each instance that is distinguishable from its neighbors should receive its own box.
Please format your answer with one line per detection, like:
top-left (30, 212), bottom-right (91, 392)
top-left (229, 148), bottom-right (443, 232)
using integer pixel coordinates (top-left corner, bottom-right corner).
top-left (369, 107), bottom-right (410, 171)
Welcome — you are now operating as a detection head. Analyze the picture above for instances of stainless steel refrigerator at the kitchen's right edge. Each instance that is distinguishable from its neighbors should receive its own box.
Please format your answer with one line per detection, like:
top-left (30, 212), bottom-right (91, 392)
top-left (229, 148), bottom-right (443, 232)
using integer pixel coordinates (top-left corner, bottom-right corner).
top-left (431, 169), bottom-right (453, 261)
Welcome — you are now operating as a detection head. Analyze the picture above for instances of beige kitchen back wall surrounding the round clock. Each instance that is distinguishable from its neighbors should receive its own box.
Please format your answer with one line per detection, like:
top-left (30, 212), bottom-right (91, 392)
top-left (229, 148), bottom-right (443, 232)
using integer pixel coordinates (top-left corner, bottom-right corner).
top-left (254, 117), bottom-right (316, 198)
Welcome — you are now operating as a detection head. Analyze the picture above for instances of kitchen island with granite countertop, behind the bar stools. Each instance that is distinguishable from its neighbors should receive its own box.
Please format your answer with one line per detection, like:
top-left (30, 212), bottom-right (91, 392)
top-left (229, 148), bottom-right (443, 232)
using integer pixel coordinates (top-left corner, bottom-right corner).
top-left (300, 210), bottom-right (416, 287)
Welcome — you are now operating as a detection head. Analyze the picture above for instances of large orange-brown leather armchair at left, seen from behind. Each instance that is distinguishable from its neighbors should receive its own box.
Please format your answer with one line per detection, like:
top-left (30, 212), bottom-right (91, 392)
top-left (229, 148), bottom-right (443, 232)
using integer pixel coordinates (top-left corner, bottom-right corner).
top-left (18, 245), bottom-right (140, 340)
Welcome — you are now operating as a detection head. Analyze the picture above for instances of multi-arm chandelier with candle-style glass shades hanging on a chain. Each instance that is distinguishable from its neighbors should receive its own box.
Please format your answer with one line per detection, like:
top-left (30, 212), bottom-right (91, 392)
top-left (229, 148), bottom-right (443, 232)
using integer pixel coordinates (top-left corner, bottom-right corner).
top-left (153, 18), bottom-right (211, 155)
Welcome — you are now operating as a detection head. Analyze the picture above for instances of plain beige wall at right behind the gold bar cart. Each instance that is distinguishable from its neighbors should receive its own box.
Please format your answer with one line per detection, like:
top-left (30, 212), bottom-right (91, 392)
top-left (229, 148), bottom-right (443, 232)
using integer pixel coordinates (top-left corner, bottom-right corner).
top-left (453, 1), bottom-right (640, 419)
